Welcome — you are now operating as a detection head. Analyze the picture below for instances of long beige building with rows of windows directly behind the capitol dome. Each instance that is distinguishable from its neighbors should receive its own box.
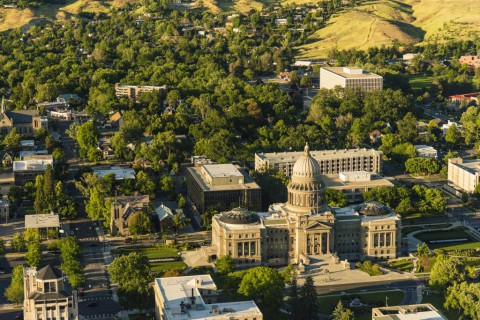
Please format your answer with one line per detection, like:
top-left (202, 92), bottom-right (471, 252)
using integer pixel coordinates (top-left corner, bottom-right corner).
top-left (255, 149), bottom-right (383, 177)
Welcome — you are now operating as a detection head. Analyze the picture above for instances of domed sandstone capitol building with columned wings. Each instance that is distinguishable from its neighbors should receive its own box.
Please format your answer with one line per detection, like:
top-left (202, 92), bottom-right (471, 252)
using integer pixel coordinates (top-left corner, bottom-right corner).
top-left (207, 145), bottom-right (401, 267)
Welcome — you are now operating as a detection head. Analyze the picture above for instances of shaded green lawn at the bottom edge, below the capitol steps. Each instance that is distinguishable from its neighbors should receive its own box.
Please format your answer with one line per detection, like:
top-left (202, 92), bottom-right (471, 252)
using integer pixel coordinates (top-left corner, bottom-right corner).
top-left (318, 290), bottom-right (403, 320)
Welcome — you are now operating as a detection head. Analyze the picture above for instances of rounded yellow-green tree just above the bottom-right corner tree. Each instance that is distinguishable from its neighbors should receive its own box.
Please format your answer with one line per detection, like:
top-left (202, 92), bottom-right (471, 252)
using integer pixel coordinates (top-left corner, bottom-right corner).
top-left (429, 255), bottom-right (467, 290)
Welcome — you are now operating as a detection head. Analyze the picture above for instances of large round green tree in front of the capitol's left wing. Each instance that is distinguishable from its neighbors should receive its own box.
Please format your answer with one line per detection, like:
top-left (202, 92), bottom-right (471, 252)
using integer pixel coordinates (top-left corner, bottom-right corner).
top-left (238, 267), bottom-right (285, 313)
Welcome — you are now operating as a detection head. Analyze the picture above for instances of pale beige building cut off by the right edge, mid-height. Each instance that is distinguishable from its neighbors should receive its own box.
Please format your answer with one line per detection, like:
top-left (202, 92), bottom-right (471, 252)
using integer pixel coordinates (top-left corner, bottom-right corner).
top-left (448, 158), bottom-right (480, 193)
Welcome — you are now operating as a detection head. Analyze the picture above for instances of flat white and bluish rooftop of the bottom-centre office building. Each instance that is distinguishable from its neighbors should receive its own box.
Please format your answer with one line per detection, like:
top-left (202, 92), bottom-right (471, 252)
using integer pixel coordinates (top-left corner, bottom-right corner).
top-left (155, 275), bottom-right (261, 320)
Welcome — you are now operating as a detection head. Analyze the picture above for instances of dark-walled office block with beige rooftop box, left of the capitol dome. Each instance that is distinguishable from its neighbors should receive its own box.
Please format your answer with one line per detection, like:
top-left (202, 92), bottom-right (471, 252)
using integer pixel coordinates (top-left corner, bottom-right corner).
top-left (187, 164), bottom-right (262, 213)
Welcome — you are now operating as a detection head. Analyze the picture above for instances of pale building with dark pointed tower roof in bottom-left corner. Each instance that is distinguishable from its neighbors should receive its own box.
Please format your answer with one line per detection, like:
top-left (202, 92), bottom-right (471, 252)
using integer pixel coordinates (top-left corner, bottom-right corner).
top-left (23, 265), bottom-right (78, 320)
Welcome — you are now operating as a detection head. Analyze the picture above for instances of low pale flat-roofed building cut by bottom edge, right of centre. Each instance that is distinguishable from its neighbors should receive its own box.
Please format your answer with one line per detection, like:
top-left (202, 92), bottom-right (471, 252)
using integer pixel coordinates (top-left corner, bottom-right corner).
top-left (372, 303), bottom-right (448, 320)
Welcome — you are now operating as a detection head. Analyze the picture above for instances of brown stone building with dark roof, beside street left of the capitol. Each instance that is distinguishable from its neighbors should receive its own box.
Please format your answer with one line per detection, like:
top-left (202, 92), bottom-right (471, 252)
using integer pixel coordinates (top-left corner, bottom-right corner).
top-left (105, 195), bottom-right (150, 236)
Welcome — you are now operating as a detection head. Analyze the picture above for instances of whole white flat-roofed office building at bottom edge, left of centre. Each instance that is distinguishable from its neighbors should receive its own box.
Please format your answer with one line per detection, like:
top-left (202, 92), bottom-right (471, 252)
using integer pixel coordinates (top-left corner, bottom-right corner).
top-left (154, 274), bottom-right (263, 320)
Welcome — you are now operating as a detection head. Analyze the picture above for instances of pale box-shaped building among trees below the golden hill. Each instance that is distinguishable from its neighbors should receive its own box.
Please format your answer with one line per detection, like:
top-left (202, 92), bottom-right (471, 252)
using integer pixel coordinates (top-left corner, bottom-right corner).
top-left (320, 67), bottom-right (383, 91)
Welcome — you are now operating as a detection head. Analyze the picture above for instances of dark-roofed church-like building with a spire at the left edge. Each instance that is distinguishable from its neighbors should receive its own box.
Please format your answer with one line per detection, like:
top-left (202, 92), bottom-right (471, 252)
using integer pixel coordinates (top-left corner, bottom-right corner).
top-left (0, 99), bottom-right (48, 136)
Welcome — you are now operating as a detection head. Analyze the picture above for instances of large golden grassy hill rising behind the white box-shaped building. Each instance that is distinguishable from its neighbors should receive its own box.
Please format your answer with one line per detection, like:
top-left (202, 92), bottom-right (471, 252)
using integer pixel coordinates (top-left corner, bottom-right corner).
top-left (298, 0), bottom-right (424, 58)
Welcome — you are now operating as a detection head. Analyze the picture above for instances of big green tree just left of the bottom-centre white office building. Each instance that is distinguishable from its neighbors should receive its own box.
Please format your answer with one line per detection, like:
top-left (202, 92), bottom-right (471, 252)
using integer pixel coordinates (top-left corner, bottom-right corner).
top-left (108, 252), bottom-right (152, 310)
